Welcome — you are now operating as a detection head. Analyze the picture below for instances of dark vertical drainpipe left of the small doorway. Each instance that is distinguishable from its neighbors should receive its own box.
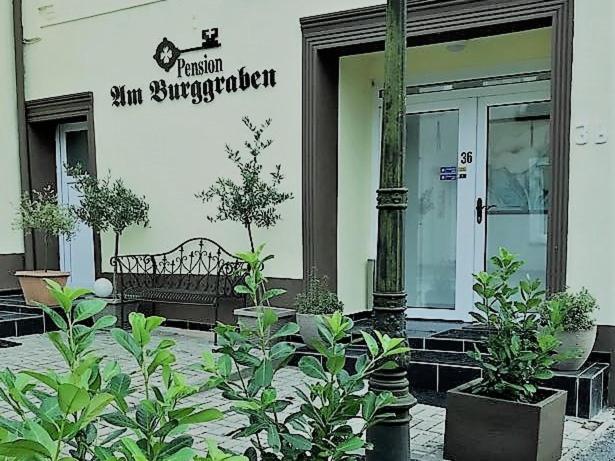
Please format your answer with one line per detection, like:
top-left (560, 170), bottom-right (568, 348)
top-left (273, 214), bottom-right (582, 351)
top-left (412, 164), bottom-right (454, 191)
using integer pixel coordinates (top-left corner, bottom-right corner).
top-left (13, 0), bottom-right (35, 270)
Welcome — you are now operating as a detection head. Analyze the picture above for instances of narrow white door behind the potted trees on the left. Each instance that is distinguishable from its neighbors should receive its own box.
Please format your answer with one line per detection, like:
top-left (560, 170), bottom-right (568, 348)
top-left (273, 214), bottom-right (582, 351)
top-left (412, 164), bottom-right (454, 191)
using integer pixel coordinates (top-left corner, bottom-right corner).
top-left (56, 123), bottom-right (95, 288)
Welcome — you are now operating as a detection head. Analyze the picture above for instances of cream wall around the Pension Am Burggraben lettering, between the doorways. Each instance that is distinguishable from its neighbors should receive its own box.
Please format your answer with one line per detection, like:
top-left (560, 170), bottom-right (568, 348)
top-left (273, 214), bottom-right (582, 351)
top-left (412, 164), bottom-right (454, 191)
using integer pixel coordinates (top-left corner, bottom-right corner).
top-left (24, 0), bottom-right (381, 278)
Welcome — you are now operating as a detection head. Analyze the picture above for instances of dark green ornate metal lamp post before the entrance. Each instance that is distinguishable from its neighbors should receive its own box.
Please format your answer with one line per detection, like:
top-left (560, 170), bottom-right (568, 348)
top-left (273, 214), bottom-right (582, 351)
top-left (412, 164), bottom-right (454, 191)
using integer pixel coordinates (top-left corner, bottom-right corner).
top-left (367, 0), bottom-right (416, 461)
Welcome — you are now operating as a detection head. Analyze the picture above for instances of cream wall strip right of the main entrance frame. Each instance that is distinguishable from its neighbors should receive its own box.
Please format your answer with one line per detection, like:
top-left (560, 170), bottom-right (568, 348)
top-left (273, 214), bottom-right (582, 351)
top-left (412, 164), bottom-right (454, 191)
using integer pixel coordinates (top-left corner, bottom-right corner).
top-left (567, 0), bottom-right (615, 325)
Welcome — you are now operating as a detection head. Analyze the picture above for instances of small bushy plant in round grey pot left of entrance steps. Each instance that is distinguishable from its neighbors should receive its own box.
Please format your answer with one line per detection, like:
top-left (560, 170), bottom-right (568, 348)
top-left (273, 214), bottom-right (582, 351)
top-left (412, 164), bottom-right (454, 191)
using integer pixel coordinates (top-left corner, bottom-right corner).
top-left (295, 269), bottom-right (344, 348)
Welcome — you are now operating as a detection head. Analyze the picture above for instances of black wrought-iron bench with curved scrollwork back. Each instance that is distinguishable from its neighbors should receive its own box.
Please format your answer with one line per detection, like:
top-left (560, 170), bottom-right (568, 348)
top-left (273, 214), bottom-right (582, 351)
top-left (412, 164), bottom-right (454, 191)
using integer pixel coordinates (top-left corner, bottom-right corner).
top-left (111, 237), bottom-right (245, 338)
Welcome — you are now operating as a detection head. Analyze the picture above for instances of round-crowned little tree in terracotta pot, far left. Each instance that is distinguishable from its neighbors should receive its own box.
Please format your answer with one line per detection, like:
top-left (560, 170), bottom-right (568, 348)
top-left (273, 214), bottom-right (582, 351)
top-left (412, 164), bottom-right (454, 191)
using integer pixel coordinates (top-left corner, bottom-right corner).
top-left (15, 186), bottom-right (77, 306)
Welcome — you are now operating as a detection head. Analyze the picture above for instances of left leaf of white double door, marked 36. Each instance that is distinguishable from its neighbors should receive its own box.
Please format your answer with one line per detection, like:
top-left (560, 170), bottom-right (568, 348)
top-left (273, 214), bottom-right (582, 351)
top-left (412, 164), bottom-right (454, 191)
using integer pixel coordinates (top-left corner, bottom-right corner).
top-left (405, 98), bottom-right (476, 320)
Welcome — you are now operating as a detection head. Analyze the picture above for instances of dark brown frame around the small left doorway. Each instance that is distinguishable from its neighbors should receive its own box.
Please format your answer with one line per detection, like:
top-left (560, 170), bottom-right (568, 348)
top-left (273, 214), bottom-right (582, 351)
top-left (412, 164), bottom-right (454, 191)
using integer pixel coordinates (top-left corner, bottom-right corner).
top-left (20, 92), bottom-right (101, 277)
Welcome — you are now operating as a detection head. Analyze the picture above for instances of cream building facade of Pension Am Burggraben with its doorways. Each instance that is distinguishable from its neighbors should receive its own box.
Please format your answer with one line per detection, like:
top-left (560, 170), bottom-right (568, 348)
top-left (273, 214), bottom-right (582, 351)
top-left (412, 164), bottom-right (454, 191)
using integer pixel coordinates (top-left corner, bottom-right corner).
top-left (0, 0), bottom-right (615, 341)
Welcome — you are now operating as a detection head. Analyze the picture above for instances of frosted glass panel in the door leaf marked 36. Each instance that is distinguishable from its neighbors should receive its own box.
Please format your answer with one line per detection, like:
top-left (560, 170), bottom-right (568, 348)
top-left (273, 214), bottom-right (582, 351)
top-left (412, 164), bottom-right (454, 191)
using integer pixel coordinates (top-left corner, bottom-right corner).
top-left (406, 110), bottom-right (459, 309)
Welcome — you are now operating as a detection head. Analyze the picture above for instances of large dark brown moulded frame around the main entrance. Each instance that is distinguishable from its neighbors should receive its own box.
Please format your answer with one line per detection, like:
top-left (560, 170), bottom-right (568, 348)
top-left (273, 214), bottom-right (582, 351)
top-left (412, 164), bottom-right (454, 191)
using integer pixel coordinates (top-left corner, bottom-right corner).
top-left (301, 0), bottom-right (573, 290)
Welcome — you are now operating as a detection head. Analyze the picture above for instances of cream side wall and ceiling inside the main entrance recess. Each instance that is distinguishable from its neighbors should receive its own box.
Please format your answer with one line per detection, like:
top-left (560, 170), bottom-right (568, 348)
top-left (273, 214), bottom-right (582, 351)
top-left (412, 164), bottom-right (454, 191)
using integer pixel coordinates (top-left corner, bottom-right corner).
top-left (337, 28), bottom-right (551, 312)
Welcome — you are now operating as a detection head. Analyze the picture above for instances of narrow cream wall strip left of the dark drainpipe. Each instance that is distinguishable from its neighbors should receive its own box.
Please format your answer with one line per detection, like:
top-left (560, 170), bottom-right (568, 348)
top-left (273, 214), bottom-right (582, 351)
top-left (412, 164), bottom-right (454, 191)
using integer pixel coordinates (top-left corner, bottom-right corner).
top-left (0, 0), bottom-right (24, 254)
